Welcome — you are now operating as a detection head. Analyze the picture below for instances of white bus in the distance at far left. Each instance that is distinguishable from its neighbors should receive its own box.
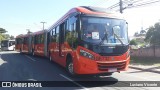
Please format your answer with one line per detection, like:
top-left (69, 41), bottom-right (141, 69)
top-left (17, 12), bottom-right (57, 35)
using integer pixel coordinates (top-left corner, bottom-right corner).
top-left (1, 40), bottom-right (15, 51)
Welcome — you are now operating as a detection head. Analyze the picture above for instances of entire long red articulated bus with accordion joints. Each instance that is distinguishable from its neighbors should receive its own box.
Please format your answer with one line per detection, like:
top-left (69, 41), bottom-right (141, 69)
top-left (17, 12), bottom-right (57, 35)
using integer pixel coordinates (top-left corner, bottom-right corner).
top-left (17, 6), bottom-right (130, 75)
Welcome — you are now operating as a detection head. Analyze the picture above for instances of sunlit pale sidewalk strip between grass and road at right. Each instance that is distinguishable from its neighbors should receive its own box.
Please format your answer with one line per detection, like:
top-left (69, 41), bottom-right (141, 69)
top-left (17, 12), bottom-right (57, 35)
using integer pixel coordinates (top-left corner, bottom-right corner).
top-left (129, 64), bottom-right (160, 74)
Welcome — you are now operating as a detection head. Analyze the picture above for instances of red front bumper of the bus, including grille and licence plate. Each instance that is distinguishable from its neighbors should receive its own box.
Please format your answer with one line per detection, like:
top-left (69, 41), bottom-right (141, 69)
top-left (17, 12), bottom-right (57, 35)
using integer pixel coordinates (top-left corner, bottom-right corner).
top-left (74, 57), bottom-right (130, 74)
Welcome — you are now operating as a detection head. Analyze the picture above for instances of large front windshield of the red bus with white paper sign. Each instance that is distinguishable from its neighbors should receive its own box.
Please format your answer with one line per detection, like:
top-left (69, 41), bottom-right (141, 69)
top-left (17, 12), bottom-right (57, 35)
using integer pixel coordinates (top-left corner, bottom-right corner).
top-left (81, 17), bottom-right (128, 46)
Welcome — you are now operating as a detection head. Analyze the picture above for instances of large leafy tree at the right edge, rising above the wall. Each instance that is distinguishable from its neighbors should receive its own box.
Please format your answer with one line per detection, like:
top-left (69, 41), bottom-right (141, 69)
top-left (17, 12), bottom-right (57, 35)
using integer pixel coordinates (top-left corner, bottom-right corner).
top-left (145, 23), bottom-right (160, 45)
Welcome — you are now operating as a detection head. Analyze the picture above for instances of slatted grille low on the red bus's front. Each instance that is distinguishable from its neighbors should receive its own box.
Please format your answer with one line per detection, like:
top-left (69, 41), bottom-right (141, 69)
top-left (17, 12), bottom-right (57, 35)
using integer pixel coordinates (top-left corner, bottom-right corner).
top-left (97, 62), bottom-right (126, 71)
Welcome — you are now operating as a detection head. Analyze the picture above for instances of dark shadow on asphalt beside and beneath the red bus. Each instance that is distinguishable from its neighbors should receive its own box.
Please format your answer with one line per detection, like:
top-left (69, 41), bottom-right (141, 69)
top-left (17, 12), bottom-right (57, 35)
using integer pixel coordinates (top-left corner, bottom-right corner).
top-left (0, 53), bottom-right (121, 90)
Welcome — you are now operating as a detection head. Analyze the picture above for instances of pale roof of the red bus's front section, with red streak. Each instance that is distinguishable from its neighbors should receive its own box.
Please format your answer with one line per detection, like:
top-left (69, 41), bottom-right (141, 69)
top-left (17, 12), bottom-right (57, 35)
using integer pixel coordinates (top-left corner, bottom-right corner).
top-left (48, 6), bottom-right (123, 31)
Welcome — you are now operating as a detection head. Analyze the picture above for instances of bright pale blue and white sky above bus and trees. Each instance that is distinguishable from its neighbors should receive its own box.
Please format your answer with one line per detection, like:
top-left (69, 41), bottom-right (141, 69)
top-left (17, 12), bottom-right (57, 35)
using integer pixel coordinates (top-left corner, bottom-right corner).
top-left (0, 0), bottom-right (160, 36)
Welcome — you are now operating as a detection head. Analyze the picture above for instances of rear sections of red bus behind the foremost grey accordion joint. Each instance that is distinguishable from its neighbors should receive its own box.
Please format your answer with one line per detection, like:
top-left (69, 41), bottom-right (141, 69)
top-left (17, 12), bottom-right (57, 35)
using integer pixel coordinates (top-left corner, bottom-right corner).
top-left (16, 30), bottom-right (47, 56)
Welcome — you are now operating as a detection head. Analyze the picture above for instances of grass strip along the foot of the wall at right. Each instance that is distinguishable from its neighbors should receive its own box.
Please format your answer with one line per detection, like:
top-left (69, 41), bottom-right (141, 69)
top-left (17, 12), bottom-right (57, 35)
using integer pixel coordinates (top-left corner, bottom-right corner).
top-left (130, 57), bottom-right (160, 66)
